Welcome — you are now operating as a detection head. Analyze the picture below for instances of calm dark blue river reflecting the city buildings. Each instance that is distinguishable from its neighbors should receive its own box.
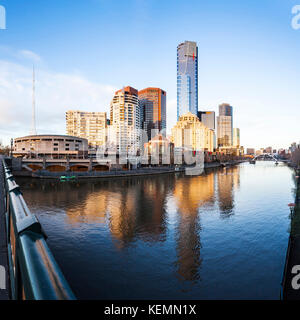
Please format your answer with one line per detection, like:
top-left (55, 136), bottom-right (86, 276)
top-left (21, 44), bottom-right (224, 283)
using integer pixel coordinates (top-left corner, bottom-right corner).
top-left (17, 162), bottom-right (295, 299)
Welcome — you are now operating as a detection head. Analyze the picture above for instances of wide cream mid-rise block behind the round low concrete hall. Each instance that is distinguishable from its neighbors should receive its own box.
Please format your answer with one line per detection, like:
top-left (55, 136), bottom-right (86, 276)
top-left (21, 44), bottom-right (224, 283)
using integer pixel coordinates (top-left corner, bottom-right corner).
top-left (66, 110), bottom-right (107, 147)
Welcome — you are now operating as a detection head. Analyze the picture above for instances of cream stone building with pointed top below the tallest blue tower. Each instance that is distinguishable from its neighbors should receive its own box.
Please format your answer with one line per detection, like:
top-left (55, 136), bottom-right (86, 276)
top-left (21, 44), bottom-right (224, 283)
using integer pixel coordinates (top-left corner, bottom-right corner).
top-left (172, 112), bottom-right (214, 152)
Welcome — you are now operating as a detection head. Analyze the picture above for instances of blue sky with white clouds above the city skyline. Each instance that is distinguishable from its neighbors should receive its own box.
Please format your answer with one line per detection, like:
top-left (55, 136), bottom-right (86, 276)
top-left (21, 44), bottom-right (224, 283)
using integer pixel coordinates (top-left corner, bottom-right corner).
top-left (0, 0), bottom-right (300, 148)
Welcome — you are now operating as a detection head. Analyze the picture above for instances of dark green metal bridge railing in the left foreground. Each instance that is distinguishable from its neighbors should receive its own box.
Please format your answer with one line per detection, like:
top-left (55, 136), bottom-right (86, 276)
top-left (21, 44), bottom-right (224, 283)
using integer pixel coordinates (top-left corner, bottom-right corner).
top-left (0, 161), bottom-right (75, 300)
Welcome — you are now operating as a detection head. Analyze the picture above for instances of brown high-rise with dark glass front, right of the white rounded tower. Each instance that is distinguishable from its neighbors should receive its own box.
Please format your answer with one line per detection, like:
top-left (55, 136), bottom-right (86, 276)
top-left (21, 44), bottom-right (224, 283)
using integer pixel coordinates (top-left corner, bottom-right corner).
top-left (139, 88), bottom-right (167, 141)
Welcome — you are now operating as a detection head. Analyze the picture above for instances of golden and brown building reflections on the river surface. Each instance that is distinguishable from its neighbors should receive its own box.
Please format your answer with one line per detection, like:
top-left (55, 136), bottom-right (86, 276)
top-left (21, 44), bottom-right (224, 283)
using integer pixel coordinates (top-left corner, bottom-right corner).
top-left (18, 167), bottom-right (240, 282)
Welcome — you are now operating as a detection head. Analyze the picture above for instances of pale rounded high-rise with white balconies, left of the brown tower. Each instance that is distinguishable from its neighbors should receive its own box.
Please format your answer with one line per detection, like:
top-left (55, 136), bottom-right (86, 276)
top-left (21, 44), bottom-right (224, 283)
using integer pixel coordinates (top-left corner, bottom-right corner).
top-left (108, 86), bottom-right (141, 153)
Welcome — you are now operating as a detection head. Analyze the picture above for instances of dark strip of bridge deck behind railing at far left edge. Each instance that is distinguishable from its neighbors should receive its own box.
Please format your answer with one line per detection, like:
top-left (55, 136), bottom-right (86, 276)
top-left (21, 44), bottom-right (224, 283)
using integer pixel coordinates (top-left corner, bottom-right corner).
top-left (0, 157), bottom-right (9, 300)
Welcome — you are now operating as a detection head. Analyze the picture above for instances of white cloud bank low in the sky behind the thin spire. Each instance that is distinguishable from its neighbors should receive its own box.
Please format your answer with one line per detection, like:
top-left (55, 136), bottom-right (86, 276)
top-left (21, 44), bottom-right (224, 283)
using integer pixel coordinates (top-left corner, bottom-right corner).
top-left (0, 60), bottom-right (117, 143)
